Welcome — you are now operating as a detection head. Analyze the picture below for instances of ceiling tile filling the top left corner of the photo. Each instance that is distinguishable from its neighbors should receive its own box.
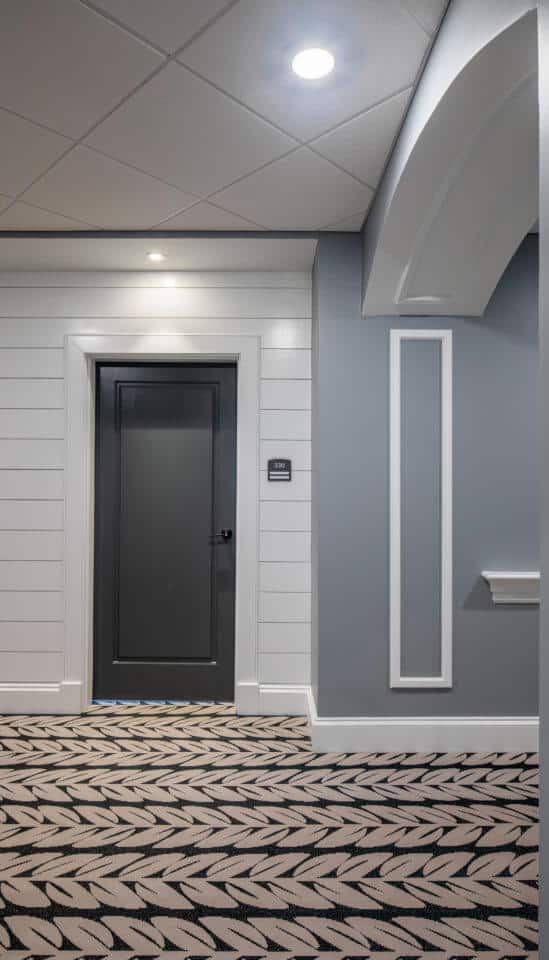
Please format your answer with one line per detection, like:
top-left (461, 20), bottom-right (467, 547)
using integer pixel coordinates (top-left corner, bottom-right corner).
top-left (0, 0), bottom-right (162, 138)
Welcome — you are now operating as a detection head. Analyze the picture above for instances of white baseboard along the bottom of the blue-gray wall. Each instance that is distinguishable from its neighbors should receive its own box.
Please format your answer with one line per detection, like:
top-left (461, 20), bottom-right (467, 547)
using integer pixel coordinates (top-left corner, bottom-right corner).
top-left (308, 690), bottom-right (539, 753)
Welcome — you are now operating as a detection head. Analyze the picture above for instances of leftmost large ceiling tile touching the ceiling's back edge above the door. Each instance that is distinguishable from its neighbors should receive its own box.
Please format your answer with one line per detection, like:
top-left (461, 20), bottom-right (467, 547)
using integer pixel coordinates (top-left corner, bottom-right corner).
top-left (24, 146), bottom-right (196, 229)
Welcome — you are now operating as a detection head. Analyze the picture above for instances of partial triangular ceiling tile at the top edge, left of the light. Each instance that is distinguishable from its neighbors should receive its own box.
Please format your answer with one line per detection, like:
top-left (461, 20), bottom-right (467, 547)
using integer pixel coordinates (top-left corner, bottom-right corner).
top-left (94, 0), bottom-right (232, 53)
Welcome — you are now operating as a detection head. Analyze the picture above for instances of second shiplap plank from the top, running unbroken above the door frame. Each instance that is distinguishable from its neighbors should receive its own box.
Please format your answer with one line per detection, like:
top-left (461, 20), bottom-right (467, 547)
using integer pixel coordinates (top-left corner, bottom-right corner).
top-left (0, 286), bottom-right (311, 319)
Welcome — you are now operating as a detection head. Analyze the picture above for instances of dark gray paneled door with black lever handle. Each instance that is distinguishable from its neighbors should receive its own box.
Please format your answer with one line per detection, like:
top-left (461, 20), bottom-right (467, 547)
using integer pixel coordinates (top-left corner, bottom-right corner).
top-left (94, 363), bottom-right (236, 700)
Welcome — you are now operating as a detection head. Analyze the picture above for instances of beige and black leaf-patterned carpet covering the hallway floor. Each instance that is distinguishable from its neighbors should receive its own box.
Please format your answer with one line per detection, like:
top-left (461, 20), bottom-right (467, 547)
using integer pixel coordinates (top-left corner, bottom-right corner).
top-left (0, 704), bottom-right (538, 960)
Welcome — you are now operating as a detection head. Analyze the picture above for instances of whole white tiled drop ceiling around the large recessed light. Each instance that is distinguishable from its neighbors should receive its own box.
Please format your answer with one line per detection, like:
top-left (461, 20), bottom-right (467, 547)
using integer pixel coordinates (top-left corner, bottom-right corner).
top-left (0, 0), bottom-right (446, 231)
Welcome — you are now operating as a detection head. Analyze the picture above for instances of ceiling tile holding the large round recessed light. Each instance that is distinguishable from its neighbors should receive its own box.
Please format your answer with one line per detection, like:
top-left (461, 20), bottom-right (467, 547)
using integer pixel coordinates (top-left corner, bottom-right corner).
top-left (180, 0), bottom-right (429, 140)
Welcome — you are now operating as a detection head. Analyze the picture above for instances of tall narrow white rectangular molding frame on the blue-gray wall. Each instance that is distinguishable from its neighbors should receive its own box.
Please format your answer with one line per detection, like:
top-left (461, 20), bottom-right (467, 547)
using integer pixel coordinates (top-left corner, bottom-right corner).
top-left (389, 329), bottom-right (453, 688)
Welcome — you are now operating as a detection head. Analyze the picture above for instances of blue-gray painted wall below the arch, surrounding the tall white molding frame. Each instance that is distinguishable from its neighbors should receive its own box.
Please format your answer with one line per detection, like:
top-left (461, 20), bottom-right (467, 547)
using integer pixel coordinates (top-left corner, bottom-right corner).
top-left (312, 235), bottom-right (539, 716)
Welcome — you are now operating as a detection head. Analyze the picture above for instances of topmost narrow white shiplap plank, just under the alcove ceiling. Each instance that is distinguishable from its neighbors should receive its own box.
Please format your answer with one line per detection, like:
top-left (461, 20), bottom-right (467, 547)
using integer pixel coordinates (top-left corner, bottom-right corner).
top-left (0, 270), bottom-right (311, 290)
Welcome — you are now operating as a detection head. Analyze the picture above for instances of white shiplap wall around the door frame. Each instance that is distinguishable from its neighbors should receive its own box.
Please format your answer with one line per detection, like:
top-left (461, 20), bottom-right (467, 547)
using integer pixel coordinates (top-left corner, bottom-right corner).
top-left (0, 273), bottom-right (311, 712)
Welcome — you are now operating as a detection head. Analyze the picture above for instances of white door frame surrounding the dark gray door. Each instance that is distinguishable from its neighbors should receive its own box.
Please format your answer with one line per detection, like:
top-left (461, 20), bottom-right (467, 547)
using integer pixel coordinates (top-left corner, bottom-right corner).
top-left (62, 334), bottom-right (260, 712)
